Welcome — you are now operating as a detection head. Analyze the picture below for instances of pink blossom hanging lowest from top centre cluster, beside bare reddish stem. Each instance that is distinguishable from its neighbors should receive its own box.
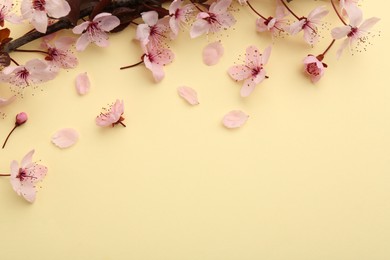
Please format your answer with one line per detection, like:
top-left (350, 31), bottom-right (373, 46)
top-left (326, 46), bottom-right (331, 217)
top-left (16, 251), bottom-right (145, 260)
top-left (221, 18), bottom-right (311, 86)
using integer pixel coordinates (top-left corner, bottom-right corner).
top-left (143, 45), bottom-right (175, 82)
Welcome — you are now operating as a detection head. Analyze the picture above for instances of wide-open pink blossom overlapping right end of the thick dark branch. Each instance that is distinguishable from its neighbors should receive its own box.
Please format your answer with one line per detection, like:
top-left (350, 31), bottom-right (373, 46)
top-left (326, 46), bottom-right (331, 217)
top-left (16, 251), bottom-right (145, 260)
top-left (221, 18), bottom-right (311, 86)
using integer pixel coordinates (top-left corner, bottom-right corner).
top-left (72, 13), bottom-right (120, 51)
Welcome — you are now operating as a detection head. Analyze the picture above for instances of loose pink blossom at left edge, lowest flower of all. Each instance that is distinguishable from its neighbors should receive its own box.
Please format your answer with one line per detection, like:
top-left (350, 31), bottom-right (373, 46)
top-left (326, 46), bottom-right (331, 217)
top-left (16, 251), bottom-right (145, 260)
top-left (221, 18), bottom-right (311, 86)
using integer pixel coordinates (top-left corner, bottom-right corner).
top-left (11, 150), bottom-right (47, 203)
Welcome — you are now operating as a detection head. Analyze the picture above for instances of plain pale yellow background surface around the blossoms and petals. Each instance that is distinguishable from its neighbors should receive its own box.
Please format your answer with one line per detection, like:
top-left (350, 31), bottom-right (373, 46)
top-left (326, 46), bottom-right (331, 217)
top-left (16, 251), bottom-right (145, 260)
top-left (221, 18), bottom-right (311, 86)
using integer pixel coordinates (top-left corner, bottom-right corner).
top-left (0, 0), bottom-right (390, 260)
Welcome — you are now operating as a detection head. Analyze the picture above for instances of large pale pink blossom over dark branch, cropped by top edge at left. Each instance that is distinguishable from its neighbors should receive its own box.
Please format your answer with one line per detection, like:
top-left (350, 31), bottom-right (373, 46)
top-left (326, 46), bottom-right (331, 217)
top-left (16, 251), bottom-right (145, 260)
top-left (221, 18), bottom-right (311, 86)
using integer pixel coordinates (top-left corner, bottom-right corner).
top-left (21, 0), bottom-right (70, 33)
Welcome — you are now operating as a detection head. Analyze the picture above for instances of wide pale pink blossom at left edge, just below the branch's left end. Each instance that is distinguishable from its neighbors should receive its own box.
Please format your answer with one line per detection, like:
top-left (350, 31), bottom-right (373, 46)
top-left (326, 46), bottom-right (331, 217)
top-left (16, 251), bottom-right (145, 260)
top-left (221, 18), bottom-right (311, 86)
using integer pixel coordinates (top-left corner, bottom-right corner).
top-left (3, 59), bottom-right (57, 89)
